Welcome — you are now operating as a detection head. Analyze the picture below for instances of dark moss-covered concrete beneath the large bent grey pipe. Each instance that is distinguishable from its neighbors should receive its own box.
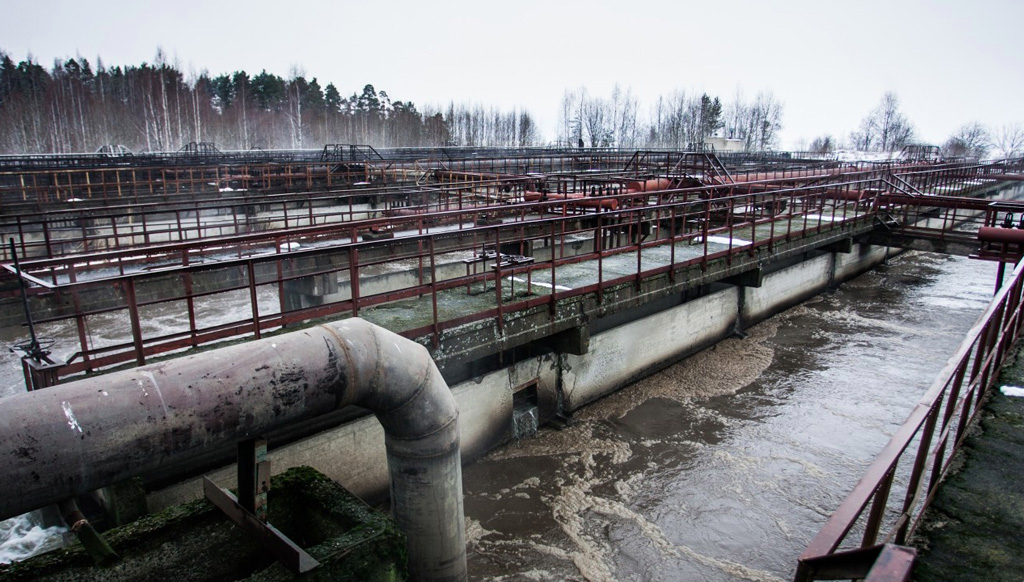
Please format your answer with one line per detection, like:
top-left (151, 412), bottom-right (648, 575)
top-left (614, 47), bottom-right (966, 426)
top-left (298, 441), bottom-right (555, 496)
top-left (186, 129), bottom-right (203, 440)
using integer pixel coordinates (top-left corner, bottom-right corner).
top-left (0, 467), bottom-right (407, 582)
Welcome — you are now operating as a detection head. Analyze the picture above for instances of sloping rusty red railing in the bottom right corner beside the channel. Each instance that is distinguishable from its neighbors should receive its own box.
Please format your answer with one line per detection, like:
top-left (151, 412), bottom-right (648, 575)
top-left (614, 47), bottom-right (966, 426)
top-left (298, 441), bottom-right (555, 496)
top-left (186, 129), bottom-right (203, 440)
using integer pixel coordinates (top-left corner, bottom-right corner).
top-left (794, 257), bottom-right (1024, 582)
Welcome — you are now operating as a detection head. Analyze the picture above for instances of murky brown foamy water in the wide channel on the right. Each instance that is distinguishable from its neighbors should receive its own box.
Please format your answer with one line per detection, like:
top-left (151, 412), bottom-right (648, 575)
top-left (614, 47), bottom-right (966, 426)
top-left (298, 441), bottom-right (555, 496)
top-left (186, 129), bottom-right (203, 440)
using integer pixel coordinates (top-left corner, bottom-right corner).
top-left (464, 253), bottom-right (995, 581)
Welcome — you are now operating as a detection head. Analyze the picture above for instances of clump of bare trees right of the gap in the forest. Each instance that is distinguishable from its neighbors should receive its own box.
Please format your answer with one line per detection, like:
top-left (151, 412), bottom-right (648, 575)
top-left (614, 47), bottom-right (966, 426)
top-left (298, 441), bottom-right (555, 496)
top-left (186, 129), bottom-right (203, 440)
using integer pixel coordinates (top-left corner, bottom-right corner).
top-left (559, 85), bottom-right (782, 152)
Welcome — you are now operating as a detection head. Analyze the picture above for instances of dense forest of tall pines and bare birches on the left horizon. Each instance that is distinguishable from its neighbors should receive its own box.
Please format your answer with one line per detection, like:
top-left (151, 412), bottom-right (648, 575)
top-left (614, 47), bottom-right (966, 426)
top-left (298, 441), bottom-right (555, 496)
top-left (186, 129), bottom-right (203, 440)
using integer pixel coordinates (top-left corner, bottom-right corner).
top-left (0, 51), bottom-right (539, 154)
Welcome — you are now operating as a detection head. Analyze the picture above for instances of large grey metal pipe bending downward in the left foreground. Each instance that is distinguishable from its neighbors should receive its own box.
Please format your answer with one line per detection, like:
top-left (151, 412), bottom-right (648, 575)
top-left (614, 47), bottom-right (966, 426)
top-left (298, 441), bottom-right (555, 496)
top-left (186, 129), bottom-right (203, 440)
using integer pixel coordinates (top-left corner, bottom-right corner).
top-left (0, 319), bottom-right (466, 581)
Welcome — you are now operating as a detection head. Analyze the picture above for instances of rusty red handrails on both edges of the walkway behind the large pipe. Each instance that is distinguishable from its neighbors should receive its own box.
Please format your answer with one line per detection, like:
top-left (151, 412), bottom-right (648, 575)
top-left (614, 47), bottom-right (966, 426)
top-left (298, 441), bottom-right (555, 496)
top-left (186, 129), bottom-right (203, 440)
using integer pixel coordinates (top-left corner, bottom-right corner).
top-left (14, 179), bottom-right (869, 383)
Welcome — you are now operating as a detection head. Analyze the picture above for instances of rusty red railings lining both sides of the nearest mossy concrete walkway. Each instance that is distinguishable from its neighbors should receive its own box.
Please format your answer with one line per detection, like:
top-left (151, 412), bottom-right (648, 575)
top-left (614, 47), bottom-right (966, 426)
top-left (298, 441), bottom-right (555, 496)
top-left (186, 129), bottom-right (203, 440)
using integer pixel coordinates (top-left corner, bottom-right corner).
top-left (12, 178), bottom-right (873, 387)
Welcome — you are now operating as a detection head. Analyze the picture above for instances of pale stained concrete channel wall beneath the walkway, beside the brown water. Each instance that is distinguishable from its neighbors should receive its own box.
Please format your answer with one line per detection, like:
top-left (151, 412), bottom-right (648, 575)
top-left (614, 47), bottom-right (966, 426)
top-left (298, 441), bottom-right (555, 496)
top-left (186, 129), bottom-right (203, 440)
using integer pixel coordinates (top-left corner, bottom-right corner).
top-left (148, 245), bottom-right (887, 510)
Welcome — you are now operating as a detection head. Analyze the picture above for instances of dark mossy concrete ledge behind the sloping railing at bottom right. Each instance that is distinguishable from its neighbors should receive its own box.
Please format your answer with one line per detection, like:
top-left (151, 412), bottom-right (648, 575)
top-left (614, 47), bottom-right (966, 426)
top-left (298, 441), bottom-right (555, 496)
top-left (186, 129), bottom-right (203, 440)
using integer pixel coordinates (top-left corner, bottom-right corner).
top-left (913, 347), bottom-right (1024, 582)
